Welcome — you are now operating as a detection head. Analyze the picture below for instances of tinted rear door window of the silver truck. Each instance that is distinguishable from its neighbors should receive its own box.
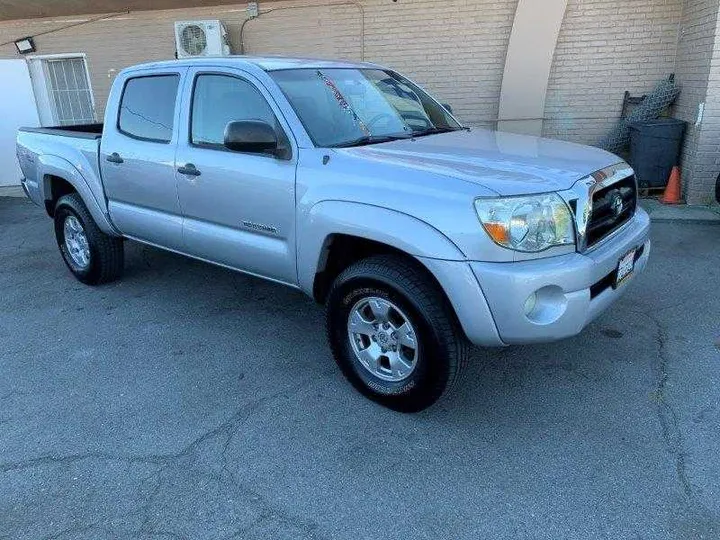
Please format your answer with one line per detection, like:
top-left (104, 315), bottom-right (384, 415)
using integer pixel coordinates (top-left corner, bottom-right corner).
top-left (118, 75), bottom-right (180, 142)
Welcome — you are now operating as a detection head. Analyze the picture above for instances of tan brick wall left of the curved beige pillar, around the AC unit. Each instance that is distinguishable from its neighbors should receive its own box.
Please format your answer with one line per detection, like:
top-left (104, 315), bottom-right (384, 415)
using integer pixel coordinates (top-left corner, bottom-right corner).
top-left (0, 0), bottom-right (517, 124)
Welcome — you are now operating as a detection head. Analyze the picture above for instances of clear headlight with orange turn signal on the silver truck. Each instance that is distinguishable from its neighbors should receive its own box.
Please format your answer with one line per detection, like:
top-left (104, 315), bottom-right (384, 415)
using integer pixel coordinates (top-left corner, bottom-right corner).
top-left (475, 193), bottom-right (575, 252)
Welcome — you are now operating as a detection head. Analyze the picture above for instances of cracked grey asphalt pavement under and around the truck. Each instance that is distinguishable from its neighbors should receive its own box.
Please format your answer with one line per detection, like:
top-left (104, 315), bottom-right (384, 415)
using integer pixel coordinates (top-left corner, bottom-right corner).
top-left (0, 198), bottom-right (720, 540)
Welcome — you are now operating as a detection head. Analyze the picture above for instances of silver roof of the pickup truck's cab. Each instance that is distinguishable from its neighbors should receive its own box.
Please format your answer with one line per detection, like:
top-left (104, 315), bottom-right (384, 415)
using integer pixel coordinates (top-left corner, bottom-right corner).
top-left (125, 55), bottom-right (380, 71)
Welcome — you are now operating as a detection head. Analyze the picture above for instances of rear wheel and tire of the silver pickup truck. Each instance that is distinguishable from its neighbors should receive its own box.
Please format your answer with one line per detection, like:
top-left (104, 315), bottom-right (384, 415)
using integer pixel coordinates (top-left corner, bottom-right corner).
top-left (54, 193), bottom-right (124, 285)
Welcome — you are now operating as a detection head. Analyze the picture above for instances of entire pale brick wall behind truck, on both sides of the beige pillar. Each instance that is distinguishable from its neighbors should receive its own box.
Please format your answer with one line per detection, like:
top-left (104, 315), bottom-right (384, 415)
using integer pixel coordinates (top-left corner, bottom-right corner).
top-left (0, 0), bottom-right (681, 139)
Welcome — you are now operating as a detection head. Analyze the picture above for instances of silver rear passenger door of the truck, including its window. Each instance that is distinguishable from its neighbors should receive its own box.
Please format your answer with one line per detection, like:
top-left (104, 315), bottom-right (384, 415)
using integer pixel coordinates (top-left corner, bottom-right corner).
top-left (100, 68), bottom-right (186, 250)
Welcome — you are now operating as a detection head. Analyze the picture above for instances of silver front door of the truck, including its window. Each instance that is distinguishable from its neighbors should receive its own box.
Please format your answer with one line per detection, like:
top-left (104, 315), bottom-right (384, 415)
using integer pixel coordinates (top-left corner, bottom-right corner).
top-left (176, 69), bottom-right (297, 284)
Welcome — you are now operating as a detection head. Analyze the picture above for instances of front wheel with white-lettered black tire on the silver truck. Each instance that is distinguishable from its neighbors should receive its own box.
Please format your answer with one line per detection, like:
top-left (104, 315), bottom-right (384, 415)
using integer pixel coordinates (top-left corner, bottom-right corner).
top-left (326, 255), bottom-right (469, 412)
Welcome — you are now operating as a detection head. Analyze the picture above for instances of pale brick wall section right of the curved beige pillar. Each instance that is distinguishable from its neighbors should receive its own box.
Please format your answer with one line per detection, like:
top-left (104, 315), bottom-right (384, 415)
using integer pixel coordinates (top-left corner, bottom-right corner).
top-left (543, 0), bottom-right (682, 144)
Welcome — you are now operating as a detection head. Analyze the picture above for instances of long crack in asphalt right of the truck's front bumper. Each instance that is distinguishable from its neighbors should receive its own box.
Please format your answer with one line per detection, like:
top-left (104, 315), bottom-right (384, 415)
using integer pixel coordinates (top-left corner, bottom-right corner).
top-left (635, 311), bottom-right (693, 499)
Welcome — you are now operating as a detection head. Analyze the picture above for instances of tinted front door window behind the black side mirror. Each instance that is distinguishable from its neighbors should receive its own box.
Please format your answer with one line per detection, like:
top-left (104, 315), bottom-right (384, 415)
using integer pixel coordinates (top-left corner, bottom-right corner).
top-left (190, 75), bottom-right (280, 147)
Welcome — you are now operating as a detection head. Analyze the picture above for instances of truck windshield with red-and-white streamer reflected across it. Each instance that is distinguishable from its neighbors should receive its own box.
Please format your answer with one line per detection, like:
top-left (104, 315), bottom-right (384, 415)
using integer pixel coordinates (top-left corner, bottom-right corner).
top-left (270, 68), bottom-right (462, 147)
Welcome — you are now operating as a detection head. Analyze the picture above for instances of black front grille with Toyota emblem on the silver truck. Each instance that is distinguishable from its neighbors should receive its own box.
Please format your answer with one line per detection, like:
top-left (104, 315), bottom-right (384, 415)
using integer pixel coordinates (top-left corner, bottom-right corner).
top-left (586, 176), bottom-right (637, 247)
